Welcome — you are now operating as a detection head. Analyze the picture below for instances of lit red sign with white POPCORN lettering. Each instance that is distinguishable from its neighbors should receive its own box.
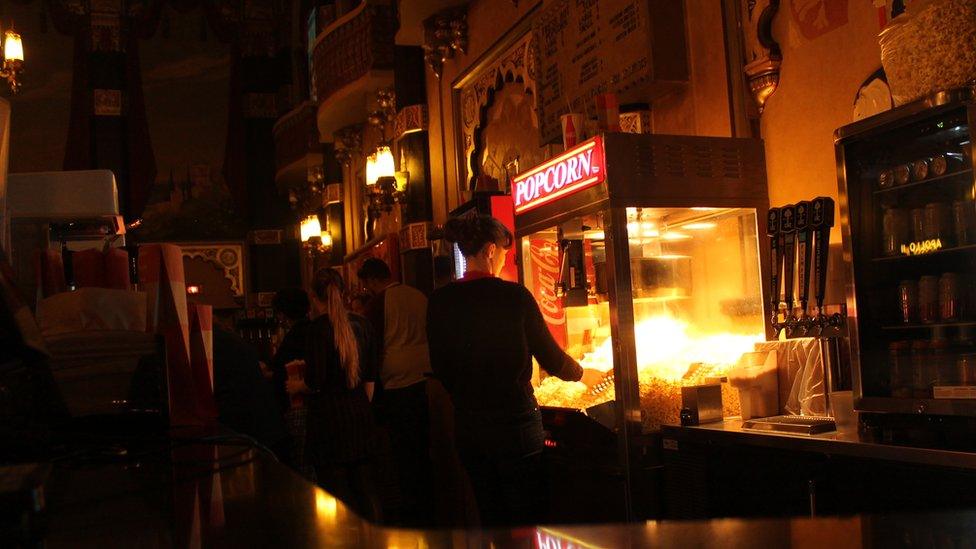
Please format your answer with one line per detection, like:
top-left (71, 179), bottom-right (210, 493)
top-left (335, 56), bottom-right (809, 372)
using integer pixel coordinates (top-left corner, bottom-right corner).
top-left (512, 136), bottom-right (607, 214)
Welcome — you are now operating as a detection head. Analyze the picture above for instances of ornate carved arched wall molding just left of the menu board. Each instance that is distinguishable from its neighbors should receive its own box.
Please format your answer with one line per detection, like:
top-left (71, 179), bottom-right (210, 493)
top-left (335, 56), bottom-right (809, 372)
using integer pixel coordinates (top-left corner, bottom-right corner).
top-left (455, 31), bottom-right (538, 189)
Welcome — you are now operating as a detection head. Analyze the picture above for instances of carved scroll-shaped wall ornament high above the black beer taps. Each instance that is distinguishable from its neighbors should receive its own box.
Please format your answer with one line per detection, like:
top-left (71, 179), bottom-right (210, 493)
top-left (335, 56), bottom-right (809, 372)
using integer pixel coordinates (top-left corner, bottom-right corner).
top-left (742, 0), bottom-right (783, 114)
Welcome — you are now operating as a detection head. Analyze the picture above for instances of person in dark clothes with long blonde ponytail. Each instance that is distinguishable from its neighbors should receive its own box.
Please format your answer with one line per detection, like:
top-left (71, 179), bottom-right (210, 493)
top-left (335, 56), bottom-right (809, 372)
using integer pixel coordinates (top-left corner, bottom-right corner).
top-left (288, 268), bottom-right (381, 520)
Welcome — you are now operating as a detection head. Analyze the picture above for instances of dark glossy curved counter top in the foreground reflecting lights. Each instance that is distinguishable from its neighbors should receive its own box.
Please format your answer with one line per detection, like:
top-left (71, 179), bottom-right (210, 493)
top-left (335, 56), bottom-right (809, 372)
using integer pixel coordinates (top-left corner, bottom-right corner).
top-left (17, 427), bottom-right (976, 549)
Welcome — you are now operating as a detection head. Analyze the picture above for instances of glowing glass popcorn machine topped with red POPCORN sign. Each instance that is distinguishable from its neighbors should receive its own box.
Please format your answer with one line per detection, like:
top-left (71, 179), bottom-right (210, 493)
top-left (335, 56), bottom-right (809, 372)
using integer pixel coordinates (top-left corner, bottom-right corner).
top-left (513, 134), bottom-right (768, 432)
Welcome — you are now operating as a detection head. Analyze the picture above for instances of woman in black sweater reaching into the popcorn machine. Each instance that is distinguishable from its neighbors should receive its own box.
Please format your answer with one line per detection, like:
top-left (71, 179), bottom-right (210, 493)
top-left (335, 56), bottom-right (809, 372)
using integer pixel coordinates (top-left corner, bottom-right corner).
top-left (427, 216), bottom-right (583, 526)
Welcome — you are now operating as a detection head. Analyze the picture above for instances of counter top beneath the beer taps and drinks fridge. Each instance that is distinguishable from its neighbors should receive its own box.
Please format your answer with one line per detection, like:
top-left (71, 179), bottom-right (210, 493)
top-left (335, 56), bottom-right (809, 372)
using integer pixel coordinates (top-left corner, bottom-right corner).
top-left (663, 418), bottom-right (976, 469)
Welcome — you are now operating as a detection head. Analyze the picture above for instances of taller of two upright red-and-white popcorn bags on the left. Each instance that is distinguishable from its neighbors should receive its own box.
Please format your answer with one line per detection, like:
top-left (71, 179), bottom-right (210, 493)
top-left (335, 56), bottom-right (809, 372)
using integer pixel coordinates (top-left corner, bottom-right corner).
top-left (139, 244), bottom-right (209, 425)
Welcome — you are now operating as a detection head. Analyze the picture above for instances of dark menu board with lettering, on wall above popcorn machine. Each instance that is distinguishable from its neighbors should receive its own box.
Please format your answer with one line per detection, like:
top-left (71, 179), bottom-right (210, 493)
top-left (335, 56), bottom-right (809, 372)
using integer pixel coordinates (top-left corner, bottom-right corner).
top-left (533, 0), bottom-right (684, 144)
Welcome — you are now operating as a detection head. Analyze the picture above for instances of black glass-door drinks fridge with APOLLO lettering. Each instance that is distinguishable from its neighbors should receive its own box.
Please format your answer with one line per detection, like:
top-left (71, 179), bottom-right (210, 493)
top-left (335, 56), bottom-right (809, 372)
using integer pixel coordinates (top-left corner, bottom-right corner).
top-left (836, 89), bottom-right (976, 416)
